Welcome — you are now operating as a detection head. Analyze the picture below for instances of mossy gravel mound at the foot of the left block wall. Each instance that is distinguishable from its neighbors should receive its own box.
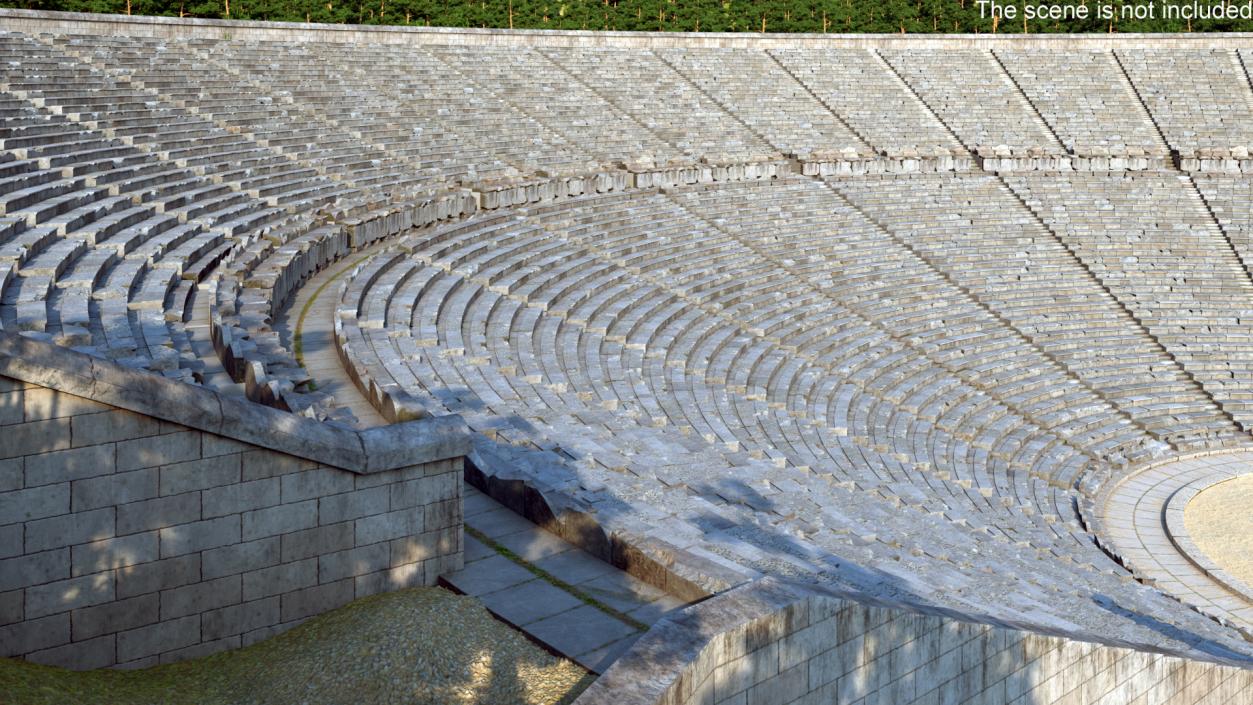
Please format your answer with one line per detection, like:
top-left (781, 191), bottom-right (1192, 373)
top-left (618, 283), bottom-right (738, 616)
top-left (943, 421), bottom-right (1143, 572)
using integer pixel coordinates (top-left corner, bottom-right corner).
top-left (0, 587), bottom-right (594, 705)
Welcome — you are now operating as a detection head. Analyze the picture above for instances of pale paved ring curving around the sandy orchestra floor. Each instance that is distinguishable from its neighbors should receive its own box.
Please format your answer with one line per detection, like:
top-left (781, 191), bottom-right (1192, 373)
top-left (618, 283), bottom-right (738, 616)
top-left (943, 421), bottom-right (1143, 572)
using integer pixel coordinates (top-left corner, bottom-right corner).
top-left (1101, 451), bottom-right (1253, 630)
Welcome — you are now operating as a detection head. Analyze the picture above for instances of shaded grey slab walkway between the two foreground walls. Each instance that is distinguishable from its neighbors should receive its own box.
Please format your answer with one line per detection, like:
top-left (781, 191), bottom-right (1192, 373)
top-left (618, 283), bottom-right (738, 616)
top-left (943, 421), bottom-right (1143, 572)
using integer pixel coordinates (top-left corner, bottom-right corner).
top-left (441, 485), bottom-right (683, 674)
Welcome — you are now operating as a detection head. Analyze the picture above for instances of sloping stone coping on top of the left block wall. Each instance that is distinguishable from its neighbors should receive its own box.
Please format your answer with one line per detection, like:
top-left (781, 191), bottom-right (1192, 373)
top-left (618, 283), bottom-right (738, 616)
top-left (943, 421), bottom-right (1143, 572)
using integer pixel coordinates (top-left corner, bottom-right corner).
top-left (0, 332), bottom-right (470, 475)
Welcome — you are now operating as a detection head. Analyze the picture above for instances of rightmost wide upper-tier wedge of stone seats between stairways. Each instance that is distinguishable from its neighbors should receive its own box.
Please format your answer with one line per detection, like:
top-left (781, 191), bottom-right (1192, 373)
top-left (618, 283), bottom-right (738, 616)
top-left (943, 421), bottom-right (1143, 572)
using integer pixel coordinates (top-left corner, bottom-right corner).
top-left (1115, 49), bottom-right (1253, 161)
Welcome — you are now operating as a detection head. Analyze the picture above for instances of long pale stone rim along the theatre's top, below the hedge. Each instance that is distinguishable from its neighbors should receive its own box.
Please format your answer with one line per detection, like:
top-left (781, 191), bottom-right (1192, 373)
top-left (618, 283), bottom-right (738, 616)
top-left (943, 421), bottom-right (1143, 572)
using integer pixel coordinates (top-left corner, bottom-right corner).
top-left (0, 9), bottom-right (1253, 51)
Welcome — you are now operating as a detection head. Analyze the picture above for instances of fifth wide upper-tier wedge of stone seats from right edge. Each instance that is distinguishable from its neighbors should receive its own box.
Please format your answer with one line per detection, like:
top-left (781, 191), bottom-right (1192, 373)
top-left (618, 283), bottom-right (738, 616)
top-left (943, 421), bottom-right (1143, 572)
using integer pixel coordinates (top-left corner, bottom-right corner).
top-left (654, 49), bottom-right (870, 159)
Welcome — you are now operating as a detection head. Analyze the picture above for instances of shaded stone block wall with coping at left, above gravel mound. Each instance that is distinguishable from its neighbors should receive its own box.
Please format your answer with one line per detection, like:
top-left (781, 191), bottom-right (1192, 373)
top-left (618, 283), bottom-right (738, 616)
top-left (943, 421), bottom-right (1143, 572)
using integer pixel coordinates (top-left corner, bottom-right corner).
top-left (0, 336), bottom-right (467, 669)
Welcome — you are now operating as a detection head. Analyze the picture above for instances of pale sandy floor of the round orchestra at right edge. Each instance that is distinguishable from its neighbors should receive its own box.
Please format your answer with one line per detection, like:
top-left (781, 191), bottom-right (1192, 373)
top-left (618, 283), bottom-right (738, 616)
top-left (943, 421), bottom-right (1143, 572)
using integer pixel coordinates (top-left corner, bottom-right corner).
top-left (1183, 473), bottom-right (1253, 585)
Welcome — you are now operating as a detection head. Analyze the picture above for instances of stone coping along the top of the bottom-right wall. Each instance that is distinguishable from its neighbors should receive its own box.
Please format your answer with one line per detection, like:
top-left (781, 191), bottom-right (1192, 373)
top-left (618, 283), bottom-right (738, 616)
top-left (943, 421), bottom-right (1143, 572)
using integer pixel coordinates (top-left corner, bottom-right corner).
top-left (574, 576), bottom-right (1249, 705)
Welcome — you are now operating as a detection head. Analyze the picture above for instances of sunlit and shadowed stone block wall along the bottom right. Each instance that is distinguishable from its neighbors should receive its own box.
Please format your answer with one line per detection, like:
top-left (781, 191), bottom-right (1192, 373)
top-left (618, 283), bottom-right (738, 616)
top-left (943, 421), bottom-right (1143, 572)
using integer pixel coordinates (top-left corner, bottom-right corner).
top-left (575, 579), bottom-right (1253, 705)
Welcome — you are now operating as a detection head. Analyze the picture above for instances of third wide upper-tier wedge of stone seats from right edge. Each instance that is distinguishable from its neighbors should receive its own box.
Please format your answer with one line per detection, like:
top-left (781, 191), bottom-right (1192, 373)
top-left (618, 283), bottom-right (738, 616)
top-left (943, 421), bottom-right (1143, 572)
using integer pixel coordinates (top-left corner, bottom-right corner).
top-left (878, 49), bottom-right (1066, 160)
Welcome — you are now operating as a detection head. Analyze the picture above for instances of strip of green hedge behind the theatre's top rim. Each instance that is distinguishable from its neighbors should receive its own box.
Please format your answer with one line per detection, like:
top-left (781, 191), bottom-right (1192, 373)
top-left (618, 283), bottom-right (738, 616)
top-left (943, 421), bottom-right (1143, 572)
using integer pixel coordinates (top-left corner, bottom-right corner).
top-left (0, 0), bottom-right (1253, 33)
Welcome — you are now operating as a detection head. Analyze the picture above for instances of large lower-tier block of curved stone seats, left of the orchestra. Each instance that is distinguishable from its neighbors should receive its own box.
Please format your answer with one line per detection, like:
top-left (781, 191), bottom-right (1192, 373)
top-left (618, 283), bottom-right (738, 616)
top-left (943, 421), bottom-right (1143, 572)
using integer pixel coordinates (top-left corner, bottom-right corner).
top-left (337, 179), bottom-right (1253, 656)
